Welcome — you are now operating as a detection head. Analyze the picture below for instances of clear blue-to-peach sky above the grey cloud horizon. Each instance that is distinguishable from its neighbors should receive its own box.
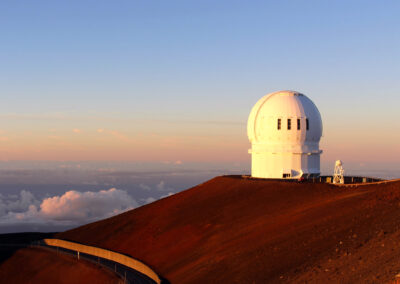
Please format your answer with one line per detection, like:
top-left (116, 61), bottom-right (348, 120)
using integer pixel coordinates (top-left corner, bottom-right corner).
top-left (0, 0), bottom-right (400, 162)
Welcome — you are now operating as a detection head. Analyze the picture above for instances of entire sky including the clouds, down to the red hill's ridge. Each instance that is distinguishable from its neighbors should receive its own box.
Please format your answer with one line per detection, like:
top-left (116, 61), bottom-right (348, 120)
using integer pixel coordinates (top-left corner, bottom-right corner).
top-left (0, 0), bottom-right (400, 233)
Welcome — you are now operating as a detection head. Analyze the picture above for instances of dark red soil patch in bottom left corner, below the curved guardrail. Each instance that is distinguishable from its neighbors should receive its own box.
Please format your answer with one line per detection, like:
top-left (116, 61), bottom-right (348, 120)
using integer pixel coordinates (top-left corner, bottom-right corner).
top-left (0, 248), bottom-right (119, 284)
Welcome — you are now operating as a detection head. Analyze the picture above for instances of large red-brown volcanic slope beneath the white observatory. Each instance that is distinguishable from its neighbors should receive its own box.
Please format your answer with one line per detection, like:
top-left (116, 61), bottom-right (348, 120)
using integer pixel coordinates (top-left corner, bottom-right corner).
top-left (0, 177), bottom-right (400, 283)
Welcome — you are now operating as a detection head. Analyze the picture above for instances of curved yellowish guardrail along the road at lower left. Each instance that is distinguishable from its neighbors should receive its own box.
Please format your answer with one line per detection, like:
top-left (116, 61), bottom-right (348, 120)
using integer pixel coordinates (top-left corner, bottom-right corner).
top-left (43, 239), bottom-right (161, 284)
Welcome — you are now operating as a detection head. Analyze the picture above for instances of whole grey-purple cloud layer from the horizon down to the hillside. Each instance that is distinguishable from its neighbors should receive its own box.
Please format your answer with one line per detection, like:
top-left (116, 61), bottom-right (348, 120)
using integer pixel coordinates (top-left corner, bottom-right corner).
top-left (0, 162), bottom-right (394, 234)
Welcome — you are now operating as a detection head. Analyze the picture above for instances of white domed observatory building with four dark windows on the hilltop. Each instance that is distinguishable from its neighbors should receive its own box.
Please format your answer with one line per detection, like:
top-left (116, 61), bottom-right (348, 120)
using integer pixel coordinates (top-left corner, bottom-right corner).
top-left (247, 91), bottom-right (322, 179)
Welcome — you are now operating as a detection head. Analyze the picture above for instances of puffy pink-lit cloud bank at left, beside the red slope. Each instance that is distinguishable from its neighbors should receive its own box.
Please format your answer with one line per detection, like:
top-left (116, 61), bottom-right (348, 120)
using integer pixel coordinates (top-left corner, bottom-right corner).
top-left (0, 188), bottom-right (138, 225)
